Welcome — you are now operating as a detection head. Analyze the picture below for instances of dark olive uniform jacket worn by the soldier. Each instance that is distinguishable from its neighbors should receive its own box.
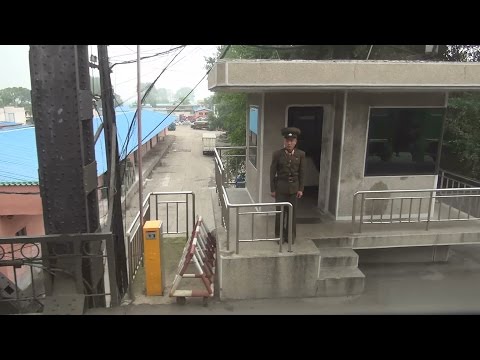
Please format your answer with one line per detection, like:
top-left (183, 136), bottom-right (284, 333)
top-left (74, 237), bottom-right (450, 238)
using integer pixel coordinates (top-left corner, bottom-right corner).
top-left (270, 148), bottom-right (305, 194)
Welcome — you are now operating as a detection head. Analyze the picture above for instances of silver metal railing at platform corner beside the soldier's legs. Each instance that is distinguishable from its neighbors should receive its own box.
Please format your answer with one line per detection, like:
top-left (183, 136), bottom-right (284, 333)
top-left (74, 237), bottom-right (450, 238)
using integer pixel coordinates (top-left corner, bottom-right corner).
top-left (214, 146), bottom-right (293, 254)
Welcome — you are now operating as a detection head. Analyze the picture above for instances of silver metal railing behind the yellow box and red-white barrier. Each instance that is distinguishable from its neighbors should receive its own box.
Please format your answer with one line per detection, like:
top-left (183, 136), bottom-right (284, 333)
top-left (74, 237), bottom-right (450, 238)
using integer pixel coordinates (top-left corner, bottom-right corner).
top-left (125, 191), bottom-right (195, 297)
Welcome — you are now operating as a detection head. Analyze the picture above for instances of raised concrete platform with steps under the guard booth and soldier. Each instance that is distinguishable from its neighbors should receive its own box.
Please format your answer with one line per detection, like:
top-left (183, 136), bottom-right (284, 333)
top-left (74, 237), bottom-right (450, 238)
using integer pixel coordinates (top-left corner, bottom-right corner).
top-left (211, 188), bottom-right (480, 300)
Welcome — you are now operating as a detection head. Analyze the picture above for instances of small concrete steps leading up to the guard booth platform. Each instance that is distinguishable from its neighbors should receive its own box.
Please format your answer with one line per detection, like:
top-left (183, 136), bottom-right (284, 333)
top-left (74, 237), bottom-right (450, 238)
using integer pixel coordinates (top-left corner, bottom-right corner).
top-left (316, 243), bottom-right (365, 296)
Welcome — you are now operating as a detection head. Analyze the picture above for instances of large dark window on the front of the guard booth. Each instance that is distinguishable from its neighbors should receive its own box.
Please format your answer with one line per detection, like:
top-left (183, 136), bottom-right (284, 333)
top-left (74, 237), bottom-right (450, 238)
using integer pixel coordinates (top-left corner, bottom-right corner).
top-left (365, 108), bottom-right (445, 176)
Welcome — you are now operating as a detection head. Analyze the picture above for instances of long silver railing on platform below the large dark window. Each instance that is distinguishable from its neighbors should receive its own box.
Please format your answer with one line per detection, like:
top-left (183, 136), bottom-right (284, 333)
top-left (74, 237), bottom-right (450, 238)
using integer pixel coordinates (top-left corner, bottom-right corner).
top-left (352, 187), bottom-right (480, 233)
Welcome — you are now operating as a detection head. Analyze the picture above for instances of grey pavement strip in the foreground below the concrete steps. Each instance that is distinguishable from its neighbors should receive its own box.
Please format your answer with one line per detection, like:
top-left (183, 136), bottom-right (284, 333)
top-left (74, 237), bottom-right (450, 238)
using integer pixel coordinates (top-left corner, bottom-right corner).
top-left (88, 245), bottom-right (480, 315)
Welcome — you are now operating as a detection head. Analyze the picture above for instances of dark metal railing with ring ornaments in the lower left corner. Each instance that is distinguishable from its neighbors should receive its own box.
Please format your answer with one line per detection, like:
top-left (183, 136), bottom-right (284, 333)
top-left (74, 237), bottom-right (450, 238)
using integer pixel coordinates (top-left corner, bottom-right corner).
top-left (0, 233), bottom-right (120, 313)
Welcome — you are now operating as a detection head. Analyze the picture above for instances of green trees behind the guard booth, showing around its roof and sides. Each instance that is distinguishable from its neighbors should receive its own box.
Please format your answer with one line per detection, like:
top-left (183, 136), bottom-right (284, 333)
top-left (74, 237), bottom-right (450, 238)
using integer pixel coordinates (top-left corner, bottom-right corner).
top-left (205, 45), bottom-right (480, 177)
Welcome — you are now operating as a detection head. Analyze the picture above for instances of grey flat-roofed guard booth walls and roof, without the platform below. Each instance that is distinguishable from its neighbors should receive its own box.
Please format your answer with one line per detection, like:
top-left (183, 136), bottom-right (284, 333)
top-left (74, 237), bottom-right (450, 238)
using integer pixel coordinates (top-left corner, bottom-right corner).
top-left (208, 60), bottom-right (480, 220)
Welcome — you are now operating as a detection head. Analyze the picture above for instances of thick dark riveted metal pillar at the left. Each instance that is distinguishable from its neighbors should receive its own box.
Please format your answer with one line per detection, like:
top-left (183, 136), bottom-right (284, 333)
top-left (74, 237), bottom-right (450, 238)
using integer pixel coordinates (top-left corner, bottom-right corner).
top-left (30, 45), bottom-right (105, 306)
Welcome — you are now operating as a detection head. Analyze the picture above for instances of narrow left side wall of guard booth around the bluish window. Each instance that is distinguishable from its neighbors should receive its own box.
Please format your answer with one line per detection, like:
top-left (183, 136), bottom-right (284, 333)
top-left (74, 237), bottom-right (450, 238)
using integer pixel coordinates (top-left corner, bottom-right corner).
top-left (245, 94), bottom-right (265, 202)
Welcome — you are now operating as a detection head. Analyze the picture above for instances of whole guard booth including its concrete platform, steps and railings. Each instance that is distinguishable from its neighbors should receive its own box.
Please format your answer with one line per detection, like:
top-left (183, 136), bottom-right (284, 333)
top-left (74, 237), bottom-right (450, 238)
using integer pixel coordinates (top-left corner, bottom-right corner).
top-left (208, 60), bottom-right (480, 299)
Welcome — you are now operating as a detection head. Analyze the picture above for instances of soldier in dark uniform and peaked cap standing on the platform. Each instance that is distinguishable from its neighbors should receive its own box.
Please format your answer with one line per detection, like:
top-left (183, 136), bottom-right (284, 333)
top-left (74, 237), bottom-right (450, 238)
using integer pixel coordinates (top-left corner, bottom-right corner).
top-left (270, 127), bottom-right (305, 243)
